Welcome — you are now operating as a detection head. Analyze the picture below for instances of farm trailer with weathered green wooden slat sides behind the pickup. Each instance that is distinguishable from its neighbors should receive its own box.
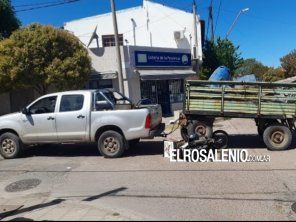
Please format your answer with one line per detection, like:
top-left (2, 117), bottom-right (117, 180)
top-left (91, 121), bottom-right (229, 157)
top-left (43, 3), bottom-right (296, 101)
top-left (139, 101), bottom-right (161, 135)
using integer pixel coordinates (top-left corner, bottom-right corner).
top-left (180, 80), bottom-right (296, 150)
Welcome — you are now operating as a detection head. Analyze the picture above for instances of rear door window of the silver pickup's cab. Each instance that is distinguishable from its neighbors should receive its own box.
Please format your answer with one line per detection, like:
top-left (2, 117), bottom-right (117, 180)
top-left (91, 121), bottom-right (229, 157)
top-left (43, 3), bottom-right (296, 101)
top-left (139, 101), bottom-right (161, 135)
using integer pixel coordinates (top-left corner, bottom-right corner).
top-left (60, 95), bottom-right (84, 112)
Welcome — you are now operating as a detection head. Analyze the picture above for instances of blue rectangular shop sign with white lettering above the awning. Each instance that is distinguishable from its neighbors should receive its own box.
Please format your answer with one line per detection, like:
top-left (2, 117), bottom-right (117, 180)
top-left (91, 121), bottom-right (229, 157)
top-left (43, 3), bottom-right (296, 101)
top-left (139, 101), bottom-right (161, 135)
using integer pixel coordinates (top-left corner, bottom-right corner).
top-left (135, 51), bottom-right (191, 67)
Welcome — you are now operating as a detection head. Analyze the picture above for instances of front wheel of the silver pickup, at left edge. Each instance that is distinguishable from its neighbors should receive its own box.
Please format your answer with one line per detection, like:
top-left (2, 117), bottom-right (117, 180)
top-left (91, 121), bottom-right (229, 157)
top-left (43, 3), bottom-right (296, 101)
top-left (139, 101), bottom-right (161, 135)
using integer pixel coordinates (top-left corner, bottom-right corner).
top-left (0, 133), bottom-right (22, 159)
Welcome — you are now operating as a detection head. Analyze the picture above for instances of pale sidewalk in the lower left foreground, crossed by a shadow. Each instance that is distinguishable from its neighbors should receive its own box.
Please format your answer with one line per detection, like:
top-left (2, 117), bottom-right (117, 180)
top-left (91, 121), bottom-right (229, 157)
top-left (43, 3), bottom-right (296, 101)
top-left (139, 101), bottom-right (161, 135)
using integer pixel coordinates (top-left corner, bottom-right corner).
top-left (0, 198), bottom-right (143, 221)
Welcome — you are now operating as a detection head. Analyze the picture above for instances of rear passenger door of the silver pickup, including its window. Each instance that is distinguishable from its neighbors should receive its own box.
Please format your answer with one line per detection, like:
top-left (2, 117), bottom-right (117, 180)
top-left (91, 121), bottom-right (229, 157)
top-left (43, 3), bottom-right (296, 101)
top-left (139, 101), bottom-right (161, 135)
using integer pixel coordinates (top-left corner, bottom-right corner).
top-left (56, 94), bottom-right (90, 142)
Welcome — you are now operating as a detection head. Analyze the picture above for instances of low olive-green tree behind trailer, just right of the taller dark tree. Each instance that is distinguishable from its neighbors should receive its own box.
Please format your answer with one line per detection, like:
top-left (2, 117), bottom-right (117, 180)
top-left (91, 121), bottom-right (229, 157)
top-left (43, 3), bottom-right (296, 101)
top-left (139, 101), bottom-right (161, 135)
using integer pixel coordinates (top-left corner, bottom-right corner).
top-left (235, 59), bottom-right (269, 80)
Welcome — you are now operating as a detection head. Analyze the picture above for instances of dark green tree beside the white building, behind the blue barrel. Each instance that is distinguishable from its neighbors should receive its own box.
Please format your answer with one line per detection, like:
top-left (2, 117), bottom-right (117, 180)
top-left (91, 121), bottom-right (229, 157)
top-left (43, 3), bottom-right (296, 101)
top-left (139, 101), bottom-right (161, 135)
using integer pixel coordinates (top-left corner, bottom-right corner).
top-left (200, 38), bottom-right (242, 79)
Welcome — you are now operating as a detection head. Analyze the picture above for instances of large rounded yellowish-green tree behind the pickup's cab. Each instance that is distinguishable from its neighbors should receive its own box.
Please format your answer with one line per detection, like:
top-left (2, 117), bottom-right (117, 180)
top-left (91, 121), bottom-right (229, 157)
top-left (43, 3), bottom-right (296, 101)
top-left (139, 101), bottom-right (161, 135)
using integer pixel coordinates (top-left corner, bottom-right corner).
top-left (0, 24), bottom-right (91, 94)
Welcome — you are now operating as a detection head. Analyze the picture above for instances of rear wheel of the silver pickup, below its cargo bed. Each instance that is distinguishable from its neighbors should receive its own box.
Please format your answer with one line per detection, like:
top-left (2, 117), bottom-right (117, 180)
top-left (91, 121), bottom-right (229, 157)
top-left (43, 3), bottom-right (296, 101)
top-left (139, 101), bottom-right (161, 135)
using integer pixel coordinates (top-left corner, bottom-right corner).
top-left (98, 130), bottom-right (125, 158)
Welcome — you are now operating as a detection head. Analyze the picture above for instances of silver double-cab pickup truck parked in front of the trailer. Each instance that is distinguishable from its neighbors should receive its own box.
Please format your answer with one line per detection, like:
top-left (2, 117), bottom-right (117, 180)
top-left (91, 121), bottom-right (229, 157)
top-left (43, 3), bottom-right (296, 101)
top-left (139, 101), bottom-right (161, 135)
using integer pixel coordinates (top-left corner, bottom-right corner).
top-left (0, 89), bottom-right (164, 159)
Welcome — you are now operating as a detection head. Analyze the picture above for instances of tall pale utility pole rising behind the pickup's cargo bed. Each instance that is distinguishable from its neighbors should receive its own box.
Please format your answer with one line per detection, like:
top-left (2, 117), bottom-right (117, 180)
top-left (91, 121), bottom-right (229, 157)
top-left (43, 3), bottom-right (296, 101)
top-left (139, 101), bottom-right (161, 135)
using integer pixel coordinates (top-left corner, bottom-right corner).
top-left (110, 0), bottom-right (124, 94)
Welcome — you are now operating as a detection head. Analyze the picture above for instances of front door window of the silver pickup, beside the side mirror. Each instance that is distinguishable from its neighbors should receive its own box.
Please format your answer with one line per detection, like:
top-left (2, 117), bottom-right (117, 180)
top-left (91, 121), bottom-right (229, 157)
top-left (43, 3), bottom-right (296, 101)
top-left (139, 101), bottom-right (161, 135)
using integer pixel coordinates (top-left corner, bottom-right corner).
top-left (29, 96), bottom-right (57, 114)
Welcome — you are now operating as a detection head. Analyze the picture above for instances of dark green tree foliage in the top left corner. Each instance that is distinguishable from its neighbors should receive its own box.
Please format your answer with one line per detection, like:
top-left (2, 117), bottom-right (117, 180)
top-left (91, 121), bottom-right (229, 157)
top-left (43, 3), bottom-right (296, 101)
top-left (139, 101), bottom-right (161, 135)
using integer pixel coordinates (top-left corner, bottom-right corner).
top-left (0, 0), bottom-right (20, 40)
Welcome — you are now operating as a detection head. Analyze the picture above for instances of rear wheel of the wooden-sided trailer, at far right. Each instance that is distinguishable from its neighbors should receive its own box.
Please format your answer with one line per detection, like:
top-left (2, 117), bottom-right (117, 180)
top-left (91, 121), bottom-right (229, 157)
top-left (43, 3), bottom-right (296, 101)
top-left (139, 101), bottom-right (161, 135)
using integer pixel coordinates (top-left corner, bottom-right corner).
top-left (263, 124), bottom-right (292, 150)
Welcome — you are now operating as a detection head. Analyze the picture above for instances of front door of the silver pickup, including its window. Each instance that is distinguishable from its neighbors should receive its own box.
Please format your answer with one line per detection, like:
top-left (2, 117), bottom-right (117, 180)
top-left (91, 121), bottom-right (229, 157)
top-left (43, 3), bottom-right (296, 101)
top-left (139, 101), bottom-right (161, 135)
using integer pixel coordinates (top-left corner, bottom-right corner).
top-left (21, 96), bottom-right (57, 143)
